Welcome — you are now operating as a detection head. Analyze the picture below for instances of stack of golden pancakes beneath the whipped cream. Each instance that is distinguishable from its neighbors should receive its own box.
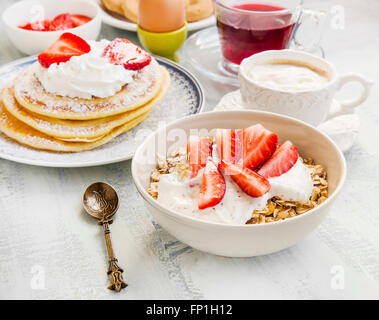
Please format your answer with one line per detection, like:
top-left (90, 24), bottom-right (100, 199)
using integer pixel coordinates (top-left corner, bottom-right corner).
top-left (0, 60), bottom-right (170, 152)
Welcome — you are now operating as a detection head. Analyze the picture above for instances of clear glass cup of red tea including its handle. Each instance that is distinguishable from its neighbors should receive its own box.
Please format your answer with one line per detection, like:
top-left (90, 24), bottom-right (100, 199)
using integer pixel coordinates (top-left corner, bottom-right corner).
top-left (215, 0), bottom-right (325, 73)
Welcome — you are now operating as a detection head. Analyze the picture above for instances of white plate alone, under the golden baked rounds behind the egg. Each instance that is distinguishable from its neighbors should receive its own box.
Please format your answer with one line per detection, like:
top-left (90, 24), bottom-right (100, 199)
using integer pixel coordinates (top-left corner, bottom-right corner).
top-left (93, 0), bottom-right (216, 32)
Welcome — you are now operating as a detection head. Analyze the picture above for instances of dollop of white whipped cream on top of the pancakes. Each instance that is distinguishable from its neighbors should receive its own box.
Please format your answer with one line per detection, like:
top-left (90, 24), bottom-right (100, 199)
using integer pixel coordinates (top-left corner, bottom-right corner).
top-left (35, 40), bottom-right (138, 99)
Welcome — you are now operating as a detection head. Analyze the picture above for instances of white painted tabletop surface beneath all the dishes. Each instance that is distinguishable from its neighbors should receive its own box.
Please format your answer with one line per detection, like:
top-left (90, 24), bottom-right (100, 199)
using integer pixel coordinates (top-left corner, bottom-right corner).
top-left (0, 0), bottom-right (379, 299)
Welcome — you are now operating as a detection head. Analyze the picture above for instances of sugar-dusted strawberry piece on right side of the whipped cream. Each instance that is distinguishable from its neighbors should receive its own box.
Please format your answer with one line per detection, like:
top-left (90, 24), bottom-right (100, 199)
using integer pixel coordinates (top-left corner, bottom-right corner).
top-left (104, 38), bottom-right (151, 70)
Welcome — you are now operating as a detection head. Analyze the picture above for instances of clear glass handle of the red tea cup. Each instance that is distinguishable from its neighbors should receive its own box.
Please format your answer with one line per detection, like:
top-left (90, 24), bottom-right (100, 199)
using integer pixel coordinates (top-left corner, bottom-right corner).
top-left (293, 9), bottom-right (327, 55)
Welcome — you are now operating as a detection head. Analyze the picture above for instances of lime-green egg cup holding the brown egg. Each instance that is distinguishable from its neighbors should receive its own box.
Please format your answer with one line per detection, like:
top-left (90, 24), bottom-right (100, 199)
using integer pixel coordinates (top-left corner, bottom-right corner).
top-left (137, 22), bottom-right (188, 62)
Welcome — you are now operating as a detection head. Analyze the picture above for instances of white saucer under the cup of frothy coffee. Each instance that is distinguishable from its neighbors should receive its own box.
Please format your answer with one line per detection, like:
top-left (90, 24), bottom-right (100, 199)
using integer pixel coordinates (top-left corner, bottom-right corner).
top-left (213, 90), bottom-right (360, 152)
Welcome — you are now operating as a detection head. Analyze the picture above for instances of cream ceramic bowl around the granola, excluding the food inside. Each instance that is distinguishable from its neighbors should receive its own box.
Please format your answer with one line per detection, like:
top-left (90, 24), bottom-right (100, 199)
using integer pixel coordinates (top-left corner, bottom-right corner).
top-left (132, 110), bottom-right (346, 257)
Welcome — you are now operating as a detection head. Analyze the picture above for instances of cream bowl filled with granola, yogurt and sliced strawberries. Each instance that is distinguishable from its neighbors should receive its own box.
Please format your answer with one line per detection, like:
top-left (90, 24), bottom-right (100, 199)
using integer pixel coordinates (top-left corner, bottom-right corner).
top-left (132, 110), bottom-right (346, 257)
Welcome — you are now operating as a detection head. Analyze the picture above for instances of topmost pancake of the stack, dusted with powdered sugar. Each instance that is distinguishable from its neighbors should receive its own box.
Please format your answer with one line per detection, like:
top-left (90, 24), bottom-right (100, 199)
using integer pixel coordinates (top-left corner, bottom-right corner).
top-left (14, 59), bottom-right (162, 120)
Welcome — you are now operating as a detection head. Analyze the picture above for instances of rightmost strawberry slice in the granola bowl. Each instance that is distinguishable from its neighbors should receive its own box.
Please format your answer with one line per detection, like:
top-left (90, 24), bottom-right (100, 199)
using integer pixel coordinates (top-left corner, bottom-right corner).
top-left (258, 140), bottom-right (299, 178)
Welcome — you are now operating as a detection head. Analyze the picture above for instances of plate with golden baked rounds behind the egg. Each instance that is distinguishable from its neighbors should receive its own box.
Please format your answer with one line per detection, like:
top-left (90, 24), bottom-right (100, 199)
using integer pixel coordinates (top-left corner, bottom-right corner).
top-left (98, 0), bottom-right (216, 31)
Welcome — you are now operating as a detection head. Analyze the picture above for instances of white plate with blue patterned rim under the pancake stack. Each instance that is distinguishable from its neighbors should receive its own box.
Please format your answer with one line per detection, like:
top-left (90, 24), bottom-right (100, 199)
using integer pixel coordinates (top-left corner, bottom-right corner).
top-left (0, 56), bottom-right (205, 167)
